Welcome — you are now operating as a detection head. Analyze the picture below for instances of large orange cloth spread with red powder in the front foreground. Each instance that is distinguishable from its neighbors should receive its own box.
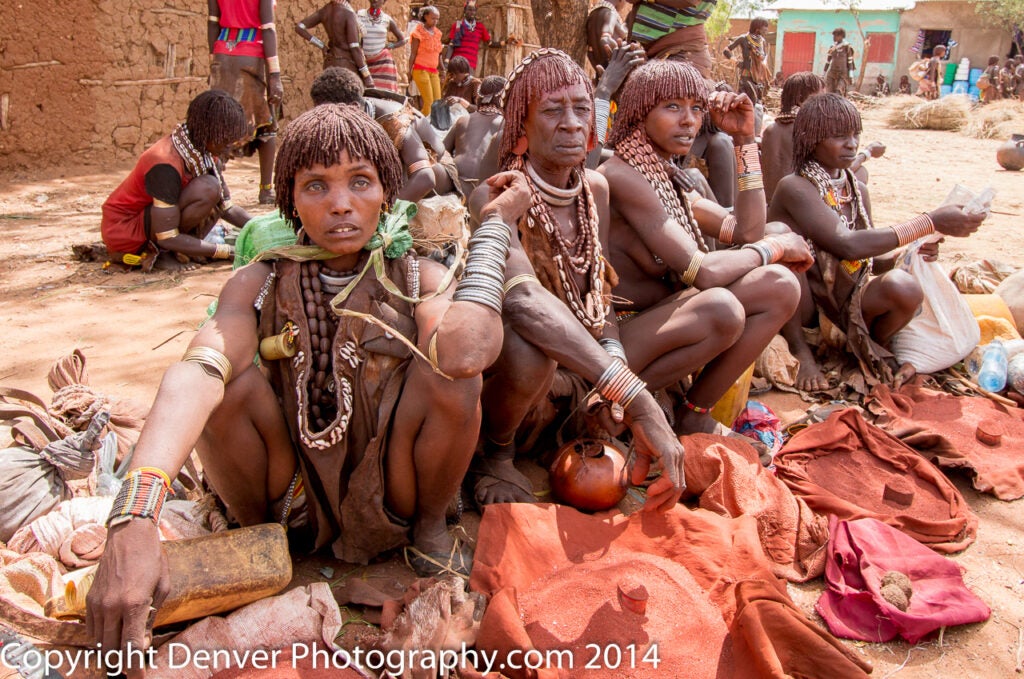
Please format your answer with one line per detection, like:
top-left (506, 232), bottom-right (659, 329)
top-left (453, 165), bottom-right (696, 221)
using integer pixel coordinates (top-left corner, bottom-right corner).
top-left (470, 504), bottom-right (869, 679)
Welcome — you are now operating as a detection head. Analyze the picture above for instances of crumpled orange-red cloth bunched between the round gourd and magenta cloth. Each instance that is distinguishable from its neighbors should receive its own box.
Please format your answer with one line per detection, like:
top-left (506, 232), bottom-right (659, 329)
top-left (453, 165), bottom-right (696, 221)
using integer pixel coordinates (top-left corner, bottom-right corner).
top-left (679, 434), bottom-right (828, 583)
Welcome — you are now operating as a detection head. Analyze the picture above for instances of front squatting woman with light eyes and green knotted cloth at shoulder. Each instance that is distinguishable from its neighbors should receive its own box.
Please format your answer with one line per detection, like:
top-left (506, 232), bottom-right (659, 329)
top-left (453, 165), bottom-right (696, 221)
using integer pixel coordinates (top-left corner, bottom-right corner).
top-left (87, 104), bottom-right (528, 649)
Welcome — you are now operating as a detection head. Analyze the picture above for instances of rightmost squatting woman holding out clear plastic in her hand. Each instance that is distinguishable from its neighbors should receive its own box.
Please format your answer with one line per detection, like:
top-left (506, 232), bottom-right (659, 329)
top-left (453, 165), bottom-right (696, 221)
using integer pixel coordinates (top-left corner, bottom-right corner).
top-left (768, 93), bottom-right (984, 391)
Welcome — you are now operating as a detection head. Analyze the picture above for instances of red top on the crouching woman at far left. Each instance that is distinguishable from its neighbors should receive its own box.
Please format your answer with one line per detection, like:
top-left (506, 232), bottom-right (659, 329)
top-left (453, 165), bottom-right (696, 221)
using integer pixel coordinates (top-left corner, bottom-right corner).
top-left (99, 135), bottom-right (193, 253)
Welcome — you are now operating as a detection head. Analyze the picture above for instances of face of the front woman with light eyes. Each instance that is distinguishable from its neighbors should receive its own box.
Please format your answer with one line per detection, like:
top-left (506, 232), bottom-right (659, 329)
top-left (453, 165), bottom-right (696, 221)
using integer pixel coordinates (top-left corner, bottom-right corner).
top-left (293, 151), bottom-right (384, 269)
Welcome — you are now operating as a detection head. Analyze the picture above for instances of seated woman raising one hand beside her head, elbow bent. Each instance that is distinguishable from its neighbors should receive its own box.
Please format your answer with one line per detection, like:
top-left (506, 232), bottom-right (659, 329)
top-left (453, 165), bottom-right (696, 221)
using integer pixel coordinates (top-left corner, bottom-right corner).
top-left (599, 60), bottom-right (811, 433)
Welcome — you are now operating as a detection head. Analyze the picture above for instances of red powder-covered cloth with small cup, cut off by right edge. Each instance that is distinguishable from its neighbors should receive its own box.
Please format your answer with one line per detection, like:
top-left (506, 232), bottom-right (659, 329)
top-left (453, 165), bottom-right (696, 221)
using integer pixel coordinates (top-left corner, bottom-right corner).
top-left (866, 384), bottom-right (1024, 500)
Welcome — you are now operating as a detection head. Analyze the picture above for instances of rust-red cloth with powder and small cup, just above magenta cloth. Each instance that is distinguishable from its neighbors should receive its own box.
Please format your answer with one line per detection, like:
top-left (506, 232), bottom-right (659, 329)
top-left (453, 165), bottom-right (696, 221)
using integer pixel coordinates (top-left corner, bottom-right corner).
top-left (775, 409), bottom-right (978, 553)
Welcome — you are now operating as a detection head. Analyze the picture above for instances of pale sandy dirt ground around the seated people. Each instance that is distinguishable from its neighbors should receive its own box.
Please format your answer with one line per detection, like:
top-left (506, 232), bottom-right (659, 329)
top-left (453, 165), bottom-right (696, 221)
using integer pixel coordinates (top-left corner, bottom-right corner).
top-left (0, 103), bottom-right (1024, 679)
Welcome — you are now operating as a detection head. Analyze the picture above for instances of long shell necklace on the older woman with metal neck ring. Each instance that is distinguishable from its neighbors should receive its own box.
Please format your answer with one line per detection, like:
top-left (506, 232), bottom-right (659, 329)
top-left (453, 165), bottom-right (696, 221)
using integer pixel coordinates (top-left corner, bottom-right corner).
top-left (512, 157), bottom-right (607, 329)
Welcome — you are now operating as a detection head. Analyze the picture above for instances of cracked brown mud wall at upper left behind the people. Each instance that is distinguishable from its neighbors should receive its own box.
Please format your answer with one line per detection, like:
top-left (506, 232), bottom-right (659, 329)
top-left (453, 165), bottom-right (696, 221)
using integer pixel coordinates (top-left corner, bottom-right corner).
top-left (0, 0), bottom-right (410, 172)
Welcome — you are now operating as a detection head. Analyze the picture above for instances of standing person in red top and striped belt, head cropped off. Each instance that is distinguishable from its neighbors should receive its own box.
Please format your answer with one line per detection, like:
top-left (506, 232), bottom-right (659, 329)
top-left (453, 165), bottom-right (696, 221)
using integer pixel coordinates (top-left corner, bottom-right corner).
top-left (206, 0), bottom-right (285, 205)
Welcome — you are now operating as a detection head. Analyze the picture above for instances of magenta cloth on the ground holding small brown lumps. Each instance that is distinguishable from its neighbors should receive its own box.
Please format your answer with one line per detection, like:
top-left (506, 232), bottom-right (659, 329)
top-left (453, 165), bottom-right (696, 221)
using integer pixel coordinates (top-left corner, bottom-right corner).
top-left (815, 516), bottom-right (991, 643)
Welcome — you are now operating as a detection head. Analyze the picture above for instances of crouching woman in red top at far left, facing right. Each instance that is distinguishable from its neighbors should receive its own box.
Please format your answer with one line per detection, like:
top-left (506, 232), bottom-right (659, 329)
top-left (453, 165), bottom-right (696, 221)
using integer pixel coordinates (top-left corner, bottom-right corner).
top-left (99, 90), bottom-right (250, 270)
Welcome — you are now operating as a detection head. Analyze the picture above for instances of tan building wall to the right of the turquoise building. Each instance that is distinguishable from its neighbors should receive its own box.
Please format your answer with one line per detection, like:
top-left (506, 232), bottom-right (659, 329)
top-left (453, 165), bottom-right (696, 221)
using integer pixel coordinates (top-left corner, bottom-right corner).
top-left (895, 0), bottom-right (1012, 82)
